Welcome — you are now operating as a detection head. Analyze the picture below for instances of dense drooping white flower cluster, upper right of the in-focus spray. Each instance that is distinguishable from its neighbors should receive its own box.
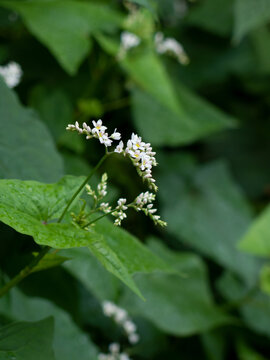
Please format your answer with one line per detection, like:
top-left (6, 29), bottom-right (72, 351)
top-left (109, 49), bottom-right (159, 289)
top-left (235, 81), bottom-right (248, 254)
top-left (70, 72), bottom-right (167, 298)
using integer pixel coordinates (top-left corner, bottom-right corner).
top-left (114, 134), bottom-right (157, 191)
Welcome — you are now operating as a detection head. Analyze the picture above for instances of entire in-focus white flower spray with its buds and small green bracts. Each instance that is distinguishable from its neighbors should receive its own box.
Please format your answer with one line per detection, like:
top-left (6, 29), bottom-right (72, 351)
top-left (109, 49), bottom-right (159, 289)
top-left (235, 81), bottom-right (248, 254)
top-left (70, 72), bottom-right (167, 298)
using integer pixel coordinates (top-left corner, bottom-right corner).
top-left (67, 120), bottom-right (166, 230)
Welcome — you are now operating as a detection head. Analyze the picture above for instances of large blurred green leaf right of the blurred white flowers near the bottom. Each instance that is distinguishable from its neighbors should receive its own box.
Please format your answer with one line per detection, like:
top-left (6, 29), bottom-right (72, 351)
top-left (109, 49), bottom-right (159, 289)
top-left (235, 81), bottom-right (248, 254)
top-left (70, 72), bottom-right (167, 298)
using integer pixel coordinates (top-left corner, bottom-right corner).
top-left (120, 240), bottom-right (230, 336)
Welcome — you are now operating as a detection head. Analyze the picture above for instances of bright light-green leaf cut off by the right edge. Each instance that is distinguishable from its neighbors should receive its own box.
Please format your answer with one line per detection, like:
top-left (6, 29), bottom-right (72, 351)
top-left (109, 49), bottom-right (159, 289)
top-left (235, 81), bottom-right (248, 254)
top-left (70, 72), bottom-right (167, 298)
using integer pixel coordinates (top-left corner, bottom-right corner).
top-left (239, 206), bottom-right (270, 257)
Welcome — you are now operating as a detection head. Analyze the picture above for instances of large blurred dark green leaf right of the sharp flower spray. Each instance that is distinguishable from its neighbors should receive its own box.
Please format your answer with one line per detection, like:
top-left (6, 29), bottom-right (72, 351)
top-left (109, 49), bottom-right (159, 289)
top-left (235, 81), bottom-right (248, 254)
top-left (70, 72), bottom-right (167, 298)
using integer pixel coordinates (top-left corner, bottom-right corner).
top-left (160, 155), bottom-right (259, 282)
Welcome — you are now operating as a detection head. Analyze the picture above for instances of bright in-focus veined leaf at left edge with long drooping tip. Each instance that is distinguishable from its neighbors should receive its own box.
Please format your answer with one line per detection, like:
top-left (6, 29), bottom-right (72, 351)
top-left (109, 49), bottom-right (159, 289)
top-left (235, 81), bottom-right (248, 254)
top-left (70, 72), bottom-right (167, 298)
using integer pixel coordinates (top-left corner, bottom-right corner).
top-left (0, 176), bottom-right (140, 296)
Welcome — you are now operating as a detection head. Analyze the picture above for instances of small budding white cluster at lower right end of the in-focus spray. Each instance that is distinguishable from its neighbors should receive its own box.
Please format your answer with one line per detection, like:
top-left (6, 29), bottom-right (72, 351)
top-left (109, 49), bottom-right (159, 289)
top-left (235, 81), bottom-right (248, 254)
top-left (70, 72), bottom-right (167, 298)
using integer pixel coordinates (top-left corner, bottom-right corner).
top-left (132, 191), bottom-right (167, 227)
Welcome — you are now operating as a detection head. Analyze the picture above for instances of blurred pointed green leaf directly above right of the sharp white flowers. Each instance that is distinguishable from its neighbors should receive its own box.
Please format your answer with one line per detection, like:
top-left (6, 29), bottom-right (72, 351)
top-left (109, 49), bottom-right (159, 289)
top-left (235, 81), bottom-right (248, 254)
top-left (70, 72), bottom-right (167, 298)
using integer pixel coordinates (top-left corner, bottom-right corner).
top-left (132, 83), bottom-right (236, 146)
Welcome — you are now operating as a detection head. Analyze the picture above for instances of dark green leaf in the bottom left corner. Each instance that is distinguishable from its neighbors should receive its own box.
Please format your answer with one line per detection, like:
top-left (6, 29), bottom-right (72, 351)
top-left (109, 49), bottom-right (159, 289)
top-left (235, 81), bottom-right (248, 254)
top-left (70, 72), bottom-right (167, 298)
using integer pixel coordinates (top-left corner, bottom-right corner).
top-left (0, 318), bottom-right (55, 360)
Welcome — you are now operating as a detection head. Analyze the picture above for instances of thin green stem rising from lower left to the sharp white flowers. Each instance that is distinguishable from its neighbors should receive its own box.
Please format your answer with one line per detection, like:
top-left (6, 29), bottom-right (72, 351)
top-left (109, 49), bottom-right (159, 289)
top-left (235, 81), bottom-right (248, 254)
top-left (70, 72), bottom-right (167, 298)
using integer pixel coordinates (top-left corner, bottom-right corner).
top-left (0, 153), bottom-right (110, 298)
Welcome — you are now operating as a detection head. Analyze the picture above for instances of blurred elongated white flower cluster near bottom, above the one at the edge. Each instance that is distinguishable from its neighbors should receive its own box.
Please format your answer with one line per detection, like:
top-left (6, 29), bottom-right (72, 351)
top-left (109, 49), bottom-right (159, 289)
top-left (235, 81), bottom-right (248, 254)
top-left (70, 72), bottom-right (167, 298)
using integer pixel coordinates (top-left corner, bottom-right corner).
top-left (102, 301), bottom-right (140, 344)
